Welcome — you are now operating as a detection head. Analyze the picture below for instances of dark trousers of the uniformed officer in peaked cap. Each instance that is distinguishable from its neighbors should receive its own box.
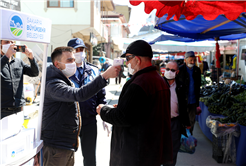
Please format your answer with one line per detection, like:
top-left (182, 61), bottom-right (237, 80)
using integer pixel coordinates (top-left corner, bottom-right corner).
top-left (80, 123), bottom-right (97, 166)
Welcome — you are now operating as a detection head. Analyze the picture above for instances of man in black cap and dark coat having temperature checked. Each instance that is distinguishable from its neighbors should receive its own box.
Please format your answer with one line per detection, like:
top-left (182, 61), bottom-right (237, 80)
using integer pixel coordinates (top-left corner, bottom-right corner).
top-left (97, 40), bottom-right (172, 166)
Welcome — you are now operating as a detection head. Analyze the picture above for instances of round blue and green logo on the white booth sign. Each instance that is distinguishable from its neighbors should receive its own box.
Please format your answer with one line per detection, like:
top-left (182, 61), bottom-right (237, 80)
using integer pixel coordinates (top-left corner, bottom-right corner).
top-left (9, 15), bottom-right (24, 38)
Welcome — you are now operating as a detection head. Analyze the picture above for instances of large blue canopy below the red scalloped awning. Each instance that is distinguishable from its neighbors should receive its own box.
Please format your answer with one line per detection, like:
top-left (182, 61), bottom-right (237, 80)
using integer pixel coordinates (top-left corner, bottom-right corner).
top-left (155, 14), bottom-right (246, 40)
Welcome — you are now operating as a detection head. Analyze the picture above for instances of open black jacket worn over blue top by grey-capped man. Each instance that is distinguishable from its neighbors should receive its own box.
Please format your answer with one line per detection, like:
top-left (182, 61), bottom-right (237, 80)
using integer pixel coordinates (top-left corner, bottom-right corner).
top-left (177, 64), bottom-right (201, 107)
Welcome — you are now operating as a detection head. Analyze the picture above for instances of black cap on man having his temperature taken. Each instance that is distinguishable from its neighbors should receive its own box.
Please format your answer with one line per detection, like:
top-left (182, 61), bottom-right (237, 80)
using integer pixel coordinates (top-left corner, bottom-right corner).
top-left (121, 40), bottom-right (153, 58)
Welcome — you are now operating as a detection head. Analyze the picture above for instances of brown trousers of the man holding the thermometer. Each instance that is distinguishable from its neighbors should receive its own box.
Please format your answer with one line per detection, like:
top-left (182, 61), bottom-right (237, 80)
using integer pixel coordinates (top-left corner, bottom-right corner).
top-left (43, 145), bottom-right (74, 166)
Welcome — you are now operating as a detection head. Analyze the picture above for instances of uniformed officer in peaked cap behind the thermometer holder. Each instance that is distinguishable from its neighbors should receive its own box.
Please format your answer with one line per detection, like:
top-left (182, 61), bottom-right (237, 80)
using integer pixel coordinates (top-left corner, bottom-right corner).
top-left (68, 38), bottom-right (106, 166)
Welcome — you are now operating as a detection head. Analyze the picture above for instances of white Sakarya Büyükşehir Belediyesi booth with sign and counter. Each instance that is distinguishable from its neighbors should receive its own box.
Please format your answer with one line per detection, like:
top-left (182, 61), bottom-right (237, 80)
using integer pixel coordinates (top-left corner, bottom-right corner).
top-left (0, 8), bottom-right (51, 165)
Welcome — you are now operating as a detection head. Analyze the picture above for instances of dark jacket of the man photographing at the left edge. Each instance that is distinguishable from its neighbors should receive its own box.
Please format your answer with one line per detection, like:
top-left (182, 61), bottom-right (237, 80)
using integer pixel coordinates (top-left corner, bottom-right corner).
top-left (0, 54), bottom-right (39, 108)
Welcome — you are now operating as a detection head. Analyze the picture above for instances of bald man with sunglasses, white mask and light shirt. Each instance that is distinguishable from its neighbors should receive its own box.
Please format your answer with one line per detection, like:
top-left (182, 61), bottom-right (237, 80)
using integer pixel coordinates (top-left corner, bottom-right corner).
top-left (164, 61), bottom-right (190, 166)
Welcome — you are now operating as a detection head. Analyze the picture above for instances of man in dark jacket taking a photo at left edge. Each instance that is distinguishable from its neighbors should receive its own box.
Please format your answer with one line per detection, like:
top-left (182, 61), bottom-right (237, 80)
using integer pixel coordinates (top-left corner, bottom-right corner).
top-left (0, 40), bottom-right (39, 120)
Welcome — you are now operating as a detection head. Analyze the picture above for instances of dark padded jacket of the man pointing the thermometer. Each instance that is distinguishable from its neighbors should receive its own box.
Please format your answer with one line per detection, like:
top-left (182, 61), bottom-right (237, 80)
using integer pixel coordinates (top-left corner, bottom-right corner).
top-left (41, 65), bottom-right (106, 151)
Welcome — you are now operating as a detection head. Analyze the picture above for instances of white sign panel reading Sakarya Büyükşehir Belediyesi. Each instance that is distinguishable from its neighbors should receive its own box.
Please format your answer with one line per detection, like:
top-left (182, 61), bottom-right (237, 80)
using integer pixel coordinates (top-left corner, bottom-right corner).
top-left (0, 8), bottom-right (51, 43)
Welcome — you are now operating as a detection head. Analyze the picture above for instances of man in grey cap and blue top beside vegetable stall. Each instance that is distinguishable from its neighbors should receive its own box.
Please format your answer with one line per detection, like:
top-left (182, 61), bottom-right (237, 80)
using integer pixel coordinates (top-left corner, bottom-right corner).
top-left (178, 51), bottom-right (201, 134)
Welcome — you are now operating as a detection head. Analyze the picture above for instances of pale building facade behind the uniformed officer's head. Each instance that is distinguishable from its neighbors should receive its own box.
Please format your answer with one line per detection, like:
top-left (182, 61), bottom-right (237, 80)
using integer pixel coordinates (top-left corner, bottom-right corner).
top-left (21, 0), bottom-right (114, 62)
